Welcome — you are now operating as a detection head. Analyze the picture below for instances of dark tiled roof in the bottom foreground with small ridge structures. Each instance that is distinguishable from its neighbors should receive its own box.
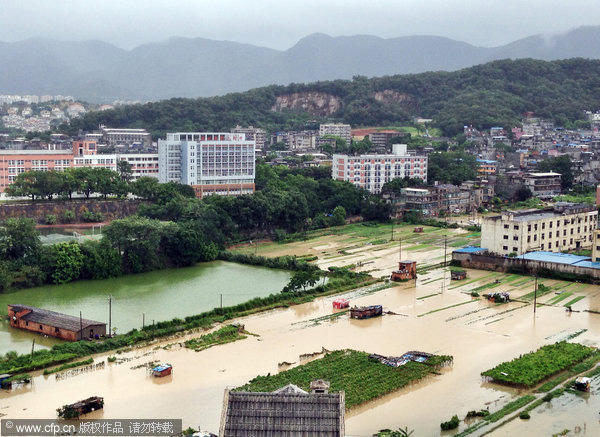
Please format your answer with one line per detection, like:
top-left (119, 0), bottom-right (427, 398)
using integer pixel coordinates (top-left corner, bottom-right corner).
top-left (219, 380), bottom-right (346, 437)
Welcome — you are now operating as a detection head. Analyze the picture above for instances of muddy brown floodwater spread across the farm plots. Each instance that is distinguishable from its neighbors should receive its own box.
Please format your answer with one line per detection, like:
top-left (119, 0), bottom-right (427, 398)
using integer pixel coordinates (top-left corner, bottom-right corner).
top-left (0, 223), bottom-right (600, 436)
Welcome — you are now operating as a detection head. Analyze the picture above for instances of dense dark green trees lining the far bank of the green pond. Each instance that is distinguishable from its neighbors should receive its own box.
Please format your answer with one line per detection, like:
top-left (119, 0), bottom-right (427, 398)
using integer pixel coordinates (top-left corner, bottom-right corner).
top-left (0, 216), bottom-right (218, 292)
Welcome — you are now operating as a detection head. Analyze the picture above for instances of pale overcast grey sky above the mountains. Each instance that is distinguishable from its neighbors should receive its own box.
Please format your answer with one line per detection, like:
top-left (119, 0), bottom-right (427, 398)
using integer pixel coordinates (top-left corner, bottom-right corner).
top-left (0, 0), bottom-right (600, 50)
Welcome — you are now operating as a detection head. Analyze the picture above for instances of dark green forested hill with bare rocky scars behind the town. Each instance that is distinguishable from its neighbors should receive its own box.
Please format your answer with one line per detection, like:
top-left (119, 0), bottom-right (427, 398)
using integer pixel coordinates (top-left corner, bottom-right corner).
top-left (62, 58), bottom-right (600, 137)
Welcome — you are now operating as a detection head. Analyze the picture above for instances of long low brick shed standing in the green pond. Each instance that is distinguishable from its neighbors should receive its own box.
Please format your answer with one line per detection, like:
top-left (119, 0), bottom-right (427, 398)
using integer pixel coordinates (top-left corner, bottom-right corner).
top-left (8, 305), bottom-right (106, 341)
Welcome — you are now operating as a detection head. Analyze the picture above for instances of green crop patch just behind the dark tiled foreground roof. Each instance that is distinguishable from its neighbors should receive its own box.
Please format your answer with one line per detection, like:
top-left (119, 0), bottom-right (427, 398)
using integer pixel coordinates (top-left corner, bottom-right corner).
top-left (236, 350), bottom-right (452, 409)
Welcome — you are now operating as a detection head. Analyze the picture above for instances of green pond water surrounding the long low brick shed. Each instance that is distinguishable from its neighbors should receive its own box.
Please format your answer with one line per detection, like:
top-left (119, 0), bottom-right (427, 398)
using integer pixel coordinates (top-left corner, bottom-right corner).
top-left (0, 261), bottom-right (290, 354)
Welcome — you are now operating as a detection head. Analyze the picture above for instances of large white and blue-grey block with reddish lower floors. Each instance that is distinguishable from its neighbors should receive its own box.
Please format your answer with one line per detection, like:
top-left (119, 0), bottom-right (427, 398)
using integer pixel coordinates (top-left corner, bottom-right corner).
top-left (158, 132), bottom-right (255, 197)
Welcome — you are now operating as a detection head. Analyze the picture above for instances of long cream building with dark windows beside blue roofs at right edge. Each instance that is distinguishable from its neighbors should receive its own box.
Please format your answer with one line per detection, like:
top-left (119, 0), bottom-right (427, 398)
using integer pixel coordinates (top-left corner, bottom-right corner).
top-left (481, 202), bottom-right (598, 255)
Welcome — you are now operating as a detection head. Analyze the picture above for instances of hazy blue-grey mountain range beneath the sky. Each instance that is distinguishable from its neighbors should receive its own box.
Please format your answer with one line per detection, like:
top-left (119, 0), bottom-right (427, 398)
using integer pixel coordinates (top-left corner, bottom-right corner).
top-left (0, 26), bottom-right (600, 102)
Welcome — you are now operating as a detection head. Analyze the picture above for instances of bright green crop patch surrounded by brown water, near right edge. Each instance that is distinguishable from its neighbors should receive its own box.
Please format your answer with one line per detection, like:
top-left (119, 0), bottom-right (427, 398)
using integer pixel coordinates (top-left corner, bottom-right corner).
top-left (481, 341), bottom-right (595, 387)
